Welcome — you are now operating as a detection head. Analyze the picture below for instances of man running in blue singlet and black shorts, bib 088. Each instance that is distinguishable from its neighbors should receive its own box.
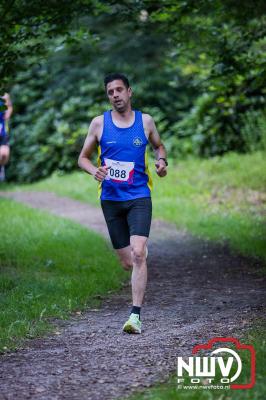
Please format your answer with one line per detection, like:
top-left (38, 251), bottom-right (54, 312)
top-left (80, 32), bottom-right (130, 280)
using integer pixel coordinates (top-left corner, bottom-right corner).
top-left (78, 74), bottom-right (167, 333)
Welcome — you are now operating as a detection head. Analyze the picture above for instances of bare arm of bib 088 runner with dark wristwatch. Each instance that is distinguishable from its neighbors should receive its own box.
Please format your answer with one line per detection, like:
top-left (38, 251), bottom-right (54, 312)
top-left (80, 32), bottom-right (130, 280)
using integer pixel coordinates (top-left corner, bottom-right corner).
top-left (145, 114), bottom-right (167, 177)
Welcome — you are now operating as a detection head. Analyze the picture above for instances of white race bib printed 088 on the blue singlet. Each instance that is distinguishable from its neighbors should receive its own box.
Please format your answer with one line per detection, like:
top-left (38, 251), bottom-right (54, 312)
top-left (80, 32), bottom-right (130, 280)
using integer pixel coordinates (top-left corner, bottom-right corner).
top-left (104, 158), bottom-right (135, 183)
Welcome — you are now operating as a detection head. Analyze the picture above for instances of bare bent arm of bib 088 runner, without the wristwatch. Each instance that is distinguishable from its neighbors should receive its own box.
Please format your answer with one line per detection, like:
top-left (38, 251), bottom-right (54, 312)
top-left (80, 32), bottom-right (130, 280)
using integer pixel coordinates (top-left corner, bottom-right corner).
top-left (78, 117), bottom-right (107, 182)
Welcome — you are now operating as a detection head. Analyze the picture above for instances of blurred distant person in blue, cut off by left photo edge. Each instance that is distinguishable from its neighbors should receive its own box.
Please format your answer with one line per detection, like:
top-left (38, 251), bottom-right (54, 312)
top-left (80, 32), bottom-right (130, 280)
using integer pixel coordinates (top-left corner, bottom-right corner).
top-left (0, 93), bottom-right (13, 182)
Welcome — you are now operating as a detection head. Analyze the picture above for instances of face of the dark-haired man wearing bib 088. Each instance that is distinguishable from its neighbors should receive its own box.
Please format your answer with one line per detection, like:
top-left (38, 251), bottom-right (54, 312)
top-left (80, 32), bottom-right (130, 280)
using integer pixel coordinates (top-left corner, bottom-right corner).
top-left (106, 79), bottom-right (132, 113)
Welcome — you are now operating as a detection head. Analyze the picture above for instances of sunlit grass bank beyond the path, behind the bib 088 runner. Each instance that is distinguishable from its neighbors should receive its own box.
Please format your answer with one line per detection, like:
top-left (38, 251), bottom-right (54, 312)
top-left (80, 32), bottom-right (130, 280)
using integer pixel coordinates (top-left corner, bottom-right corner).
top-left (2, 152), bottom-right (266, 260)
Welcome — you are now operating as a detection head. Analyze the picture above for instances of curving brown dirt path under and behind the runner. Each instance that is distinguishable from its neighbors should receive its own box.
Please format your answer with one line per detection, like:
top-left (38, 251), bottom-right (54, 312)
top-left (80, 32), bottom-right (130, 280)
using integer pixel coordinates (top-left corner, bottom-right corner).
top-left (0, 192), bottom-right (266, 400)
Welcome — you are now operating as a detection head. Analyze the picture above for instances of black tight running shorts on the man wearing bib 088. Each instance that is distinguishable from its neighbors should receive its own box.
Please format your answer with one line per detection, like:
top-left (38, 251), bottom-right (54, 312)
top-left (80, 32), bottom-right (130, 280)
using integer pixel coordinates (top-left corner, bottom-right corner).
top-left (101, 197), bottom-right (152, 249)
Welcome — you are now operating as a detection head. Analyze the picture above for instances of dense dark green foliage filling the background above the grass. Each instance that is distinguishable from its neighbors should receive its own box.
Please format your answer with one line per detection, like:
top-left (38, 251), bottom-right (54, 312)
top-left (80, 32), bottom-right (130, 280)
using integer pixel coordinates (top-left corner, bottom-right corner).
top-left (1, 0), bottom-right (266, 181)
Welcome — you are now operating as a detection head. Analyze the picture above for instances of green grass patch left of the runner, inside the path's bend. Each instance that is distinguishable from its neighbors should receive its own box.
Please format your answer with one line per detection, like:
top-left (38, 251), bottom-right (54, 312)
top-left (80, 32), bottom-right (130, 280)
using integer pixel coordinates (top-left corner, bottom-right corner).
top-left (0, 199), bottom-right (127, 351)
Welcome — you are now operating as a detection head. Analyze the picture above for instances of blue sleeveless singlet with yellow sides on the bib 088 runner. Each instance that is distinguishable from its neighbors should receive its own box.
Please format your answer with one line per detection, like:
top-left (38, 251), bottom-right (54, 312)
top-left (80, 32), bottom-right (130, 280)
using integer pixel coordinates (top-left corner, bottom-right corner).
top-left (98, 110), bottom-right (152, 201)
